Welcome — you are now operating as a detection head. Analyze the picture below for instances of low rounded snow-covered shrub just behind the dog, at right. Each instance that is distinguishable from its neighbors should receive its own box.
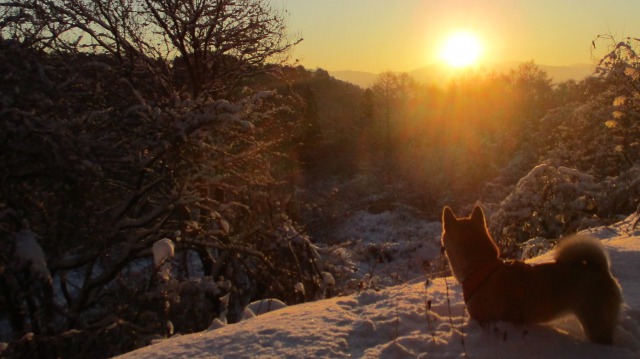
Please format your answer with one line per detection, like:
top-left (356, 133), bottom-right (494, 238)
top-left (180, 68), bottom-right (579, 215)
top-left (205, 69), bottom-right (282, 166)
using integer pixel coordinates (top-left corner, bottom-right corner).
top-left (489, 163), bottom-right (640, 255)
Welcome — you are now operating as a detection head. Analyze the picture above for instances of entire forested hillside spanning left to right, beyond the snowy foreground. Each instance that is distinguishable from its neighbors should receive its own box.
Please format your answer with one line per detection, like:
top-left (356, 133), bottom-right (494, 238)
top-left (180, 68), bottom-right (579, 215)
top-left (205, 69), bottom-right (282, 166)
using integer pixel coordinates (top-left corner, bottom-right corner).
top-left (0, 0), bottom-right (640, 358)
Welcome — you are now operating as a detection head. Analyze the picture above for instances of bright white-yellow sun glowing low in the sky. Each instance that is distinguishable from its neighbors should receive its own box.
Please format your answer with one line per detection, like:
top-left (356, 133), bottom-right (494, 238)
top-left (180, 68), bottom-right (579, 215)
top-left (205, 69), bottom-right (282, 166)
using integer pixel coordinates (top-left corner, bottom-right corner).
top-left (440, 32), bottom-right (482, 68)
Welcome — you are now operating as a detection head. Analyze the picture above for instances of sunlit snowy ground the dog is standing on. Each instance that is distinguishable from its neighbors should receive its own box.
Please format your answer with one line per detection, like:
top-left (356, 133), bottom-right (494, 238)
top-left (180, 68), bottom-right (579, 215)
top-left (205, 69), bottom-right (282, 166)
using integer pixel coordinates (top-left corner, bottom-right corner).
top-left (123, 212), bottom-right (640, 359)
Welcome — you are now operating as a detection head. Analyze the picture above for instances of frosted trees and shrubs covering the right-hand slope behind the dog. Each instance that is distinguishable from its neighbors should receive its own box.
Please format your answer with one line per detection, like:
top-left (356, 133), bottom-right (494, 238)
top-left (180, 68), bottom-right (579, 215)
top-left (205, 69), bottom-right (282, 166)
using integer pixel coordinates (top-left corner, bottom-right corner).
top-left (483, 52), bottom-right (640, 252)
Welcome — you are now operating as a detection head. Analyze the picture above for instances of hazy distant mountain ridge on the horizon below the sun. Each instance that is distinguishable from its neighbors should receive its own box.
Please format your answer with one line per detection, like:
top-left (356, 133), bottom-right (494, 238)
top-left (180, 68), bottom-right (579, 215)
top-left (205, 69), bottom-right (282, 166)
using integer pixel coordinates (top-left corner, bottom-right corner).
top-left (329, 62), bottom-right (595, 88)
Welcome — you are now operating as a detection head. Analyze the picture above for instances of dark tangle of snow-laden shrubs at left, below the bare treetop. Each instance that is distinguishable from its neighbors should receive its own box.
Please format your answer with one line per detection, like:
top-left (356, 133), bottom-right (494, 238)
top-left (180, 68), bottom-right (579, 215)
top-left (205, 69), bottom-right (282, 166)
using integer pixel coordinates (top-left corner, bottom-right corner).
top-left (0, 40), bottom-right (326, 357)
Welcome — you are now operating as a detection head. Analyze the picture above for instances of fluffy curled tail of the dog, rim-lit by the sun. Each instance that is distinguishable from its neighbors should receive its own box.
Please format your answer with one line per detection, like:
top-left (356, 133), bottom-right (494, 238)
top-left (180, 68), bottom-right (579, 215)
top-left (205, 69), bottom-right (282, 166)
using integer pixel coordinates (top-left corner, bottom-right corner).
top-left (555, 235), bottom-right (609, 271)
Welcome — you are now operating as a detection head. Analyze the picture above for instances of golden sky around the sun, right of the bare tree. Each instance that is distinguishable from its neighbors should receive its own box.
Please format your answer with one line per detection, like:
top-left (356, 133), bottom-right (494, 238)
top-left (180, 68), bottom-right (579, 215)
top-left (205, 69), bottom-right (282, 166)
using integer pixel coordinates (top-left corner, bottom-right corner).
top-left (268, 0), bottom-right (640, 73)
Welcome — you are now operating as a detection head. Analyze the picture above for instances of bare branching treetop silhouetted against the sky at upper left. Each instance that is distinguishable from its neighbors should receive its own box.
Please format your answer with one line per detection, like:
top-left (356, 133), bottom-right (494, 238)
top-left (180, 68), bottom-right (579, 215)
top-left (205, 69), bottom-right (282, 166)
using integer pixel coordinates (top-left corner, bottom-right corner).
top-left (0, 0), bottom-right (301, 97)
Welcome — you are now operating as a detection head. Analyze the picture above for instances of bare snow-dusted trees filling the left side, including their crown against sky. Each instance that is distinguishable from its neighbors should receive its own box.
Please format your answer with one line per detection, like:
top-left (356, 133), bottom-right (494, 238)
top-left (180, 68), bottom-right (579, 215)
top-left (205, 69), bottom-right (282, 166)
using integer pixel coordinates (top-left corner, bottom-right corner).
top-left (0, 0), bottom-right (324, 357)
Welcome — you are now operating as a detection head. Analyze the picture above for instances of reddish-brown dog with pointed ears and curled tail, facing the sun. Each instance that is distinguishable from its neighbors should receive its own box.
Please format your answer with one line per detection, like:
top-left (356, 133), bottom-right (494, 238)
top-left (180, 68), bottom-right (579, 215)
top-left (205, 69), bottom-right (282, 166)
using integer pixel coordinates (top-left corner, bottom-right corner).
top-left (442, 207), bottom-right (622, 344)
